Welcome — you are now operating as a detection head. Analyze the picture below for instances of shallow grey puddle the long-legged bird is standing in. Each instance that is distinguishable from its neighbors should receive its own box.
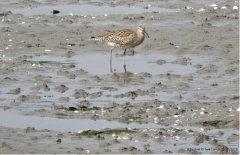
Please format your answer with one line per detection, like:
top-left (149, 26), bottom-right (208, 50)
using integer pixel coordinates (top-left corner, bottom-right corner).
top-left (28, 54), bottom-right (197, 76)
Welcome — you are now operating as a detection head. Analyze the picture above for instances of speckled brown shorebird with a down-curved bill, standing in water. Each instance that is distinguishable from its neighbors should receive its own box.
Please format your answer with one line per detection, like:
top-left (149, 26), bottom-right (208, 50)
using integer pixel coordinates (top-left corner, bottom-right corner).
top-left (90, 26), bottom-right (149, 72)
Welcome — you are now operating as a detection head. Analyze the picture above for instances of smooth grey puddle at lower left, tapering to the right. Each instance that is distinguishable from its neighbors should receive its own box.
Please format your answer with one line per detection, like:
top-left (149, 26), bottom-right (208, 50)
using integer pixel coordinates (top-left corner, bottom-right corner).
top-left (0, 110), bottom-right (163, 132)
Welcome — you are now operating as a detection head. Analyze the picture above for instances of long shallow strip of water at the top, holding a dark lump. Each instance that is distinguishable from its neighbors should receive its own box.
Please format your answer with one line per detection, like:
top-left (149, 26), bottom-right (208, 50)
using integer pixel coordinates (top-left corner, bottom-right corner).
top-left (10, 5), bottom-right (176, 16)
